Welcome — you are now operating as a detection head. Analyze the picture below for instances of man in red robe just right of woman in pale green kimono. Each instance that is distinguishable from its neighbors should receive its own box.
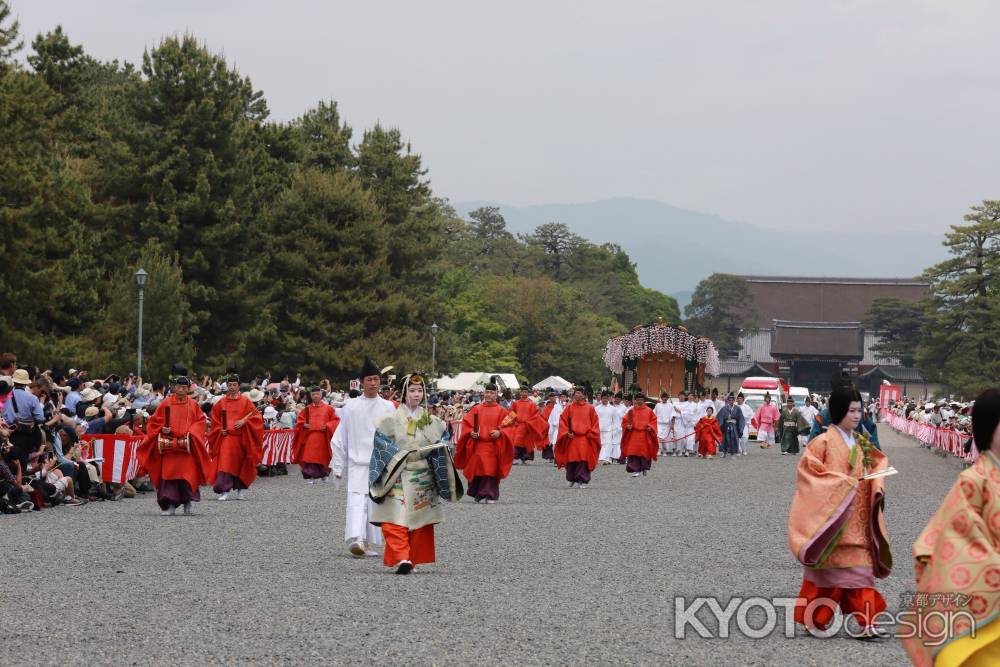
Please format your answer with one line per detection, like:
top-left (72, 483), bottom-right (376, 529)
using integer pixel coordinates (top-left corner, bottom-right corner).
top-left (455, 384), bottom-right (514, 505)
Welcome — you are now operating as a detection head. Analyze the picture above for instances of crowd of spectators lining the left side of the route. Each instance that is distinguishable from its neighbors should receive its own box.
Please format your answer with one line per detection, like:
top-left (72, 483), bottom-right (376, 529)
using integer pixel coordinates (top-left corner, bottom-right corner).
top-left (0, 352), bottom-right (538, 514)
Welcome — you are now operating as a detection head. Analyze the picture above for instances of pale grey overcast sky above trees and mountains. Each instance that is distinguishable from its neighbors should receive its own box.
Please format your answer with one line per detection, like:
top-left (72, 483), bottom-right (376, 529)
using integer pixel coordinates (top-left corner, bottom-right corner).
top-left (11, 0), bottom-right (1000, 232)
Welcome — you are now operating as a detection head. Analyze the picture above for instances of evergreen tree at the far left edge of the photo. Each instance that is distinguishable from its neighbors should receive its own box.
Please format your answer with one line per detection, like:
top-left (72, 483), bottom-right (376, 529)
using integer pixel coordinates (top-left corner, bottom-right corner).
top-left (0, 42), bottom-right (97, 365)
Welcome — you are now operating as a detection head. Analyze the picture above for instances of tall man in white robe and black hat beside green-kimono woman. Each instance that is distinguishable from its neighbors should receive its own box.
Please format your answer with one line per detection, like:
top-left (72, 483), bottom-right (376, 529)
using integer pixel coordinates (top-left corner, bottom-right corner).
top-left (332, 359), bottom-right (396, 557)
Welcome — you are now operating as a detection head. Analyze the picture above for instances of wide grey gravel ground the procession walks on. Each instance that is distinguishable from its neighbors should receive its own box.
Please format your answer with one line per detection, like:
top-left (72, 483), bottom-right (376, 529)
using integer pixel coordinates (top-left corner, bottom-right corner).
top-left (0, 426), bottom-right (959, 666)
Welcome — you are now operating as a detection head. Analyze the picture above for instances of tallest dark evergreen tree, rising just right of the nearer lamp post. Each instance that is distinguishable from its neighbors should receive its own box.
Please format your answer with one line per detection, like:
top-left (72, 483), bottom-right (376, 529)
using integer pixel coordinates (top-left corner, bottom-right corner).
top-left (136, 35), bottom-right (268, 370)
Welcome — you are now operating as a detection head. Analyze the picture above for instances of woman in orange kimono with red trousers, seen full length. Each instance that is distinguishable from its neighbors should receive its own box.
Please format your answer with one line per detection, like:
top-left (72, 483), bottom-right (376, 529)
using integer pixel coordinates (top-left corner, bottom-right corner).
top-left (788, 386), bottom-right (892, 639)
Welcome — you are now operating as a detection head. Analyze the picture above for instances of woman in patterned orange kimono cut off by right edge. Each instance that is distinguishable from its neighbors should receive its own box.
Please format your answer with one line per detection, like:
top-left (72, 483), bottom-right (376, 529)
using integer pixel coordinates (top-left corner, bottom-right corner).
top-left (900, 389), bottom-right (1000, 667)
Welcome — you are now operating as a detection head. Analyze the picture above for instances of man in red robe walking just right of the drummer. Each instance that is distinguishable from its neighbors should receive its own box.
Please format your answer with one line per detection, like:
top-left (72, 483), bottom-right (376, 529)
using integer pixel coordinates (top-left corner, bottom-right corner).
top-left (208, 375), bottom-right (264, 500)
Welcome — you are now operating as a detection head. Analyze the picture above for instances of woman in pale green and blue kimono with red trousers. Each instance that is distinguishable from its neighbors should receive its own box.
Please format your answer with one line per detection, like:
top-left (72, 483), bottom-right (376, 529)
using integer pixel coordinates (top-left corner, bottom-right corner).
top-left (368, 373), bottom-right (464, 574)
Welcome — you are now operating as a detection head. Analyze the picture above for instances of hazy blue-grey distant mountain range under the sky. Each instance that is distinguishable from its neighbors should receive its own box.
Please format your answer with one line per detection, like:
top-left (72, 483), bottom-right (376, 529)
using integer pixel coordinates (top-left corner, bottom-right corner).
top-left (452, 197), bottom-right (947, 308)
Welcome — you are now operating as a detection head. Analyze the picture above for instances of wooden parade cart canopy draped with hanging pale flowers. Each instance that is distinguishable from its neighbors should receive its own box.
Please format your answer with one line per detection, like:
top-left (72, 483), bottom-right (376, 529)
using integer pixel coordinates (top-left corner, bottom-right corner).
top-left (604, 317), bottom-right (719, 396)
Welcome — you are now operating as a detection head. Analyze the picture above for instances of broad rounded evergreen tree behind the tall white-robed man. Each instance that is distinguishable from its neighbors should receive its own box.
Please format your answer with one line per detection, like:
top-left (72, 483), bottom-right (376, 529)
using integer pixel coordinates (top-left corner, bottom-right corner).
top-left (248, 169), bottom-right (406, 381)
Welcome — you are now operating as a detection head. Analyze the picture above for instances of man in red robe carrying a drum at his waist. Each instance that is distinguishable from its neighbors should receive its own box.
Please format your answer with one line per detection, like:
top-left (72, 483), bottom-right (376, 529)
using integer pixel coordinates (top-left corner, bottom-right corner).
top-left (138, 375), bottom-right (212, 516)
